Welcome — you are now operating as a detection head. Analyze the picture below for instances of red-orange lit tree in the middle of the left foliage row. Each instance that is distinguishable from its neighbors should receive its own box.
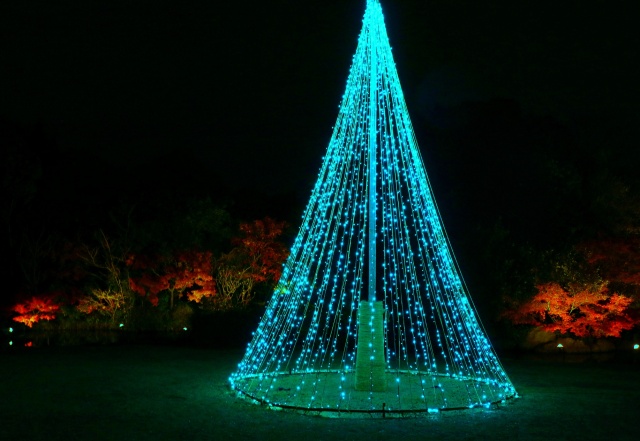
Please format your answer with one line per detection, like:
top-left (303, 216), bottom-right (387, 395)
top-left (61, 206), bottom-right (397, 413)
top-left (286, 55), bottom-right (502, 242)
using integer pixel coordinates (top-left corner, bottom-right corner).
top-left (127, 251), bottom-right (216, 307)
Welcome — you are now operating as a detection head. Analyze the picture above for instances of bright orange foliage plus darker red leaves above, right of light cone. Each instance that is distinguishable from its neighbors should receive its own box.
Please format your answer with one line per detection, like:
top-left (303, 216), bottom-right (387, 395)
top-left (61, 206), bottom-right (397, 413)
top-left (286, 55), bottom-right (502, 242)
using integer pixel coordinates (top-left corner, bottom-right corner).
top-left (504, 238), bottom-right (640, 338)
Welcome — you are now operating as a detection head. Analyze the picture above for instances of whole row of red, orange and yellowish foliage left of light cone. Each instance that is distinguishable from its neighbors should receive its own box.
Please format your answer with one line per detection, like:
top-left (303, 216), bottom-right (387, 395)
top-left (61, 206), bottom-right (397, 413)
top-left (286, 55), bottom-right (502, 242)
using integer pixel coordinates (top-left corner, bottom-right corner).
top-left (11, 218), bottom-right (288, 327)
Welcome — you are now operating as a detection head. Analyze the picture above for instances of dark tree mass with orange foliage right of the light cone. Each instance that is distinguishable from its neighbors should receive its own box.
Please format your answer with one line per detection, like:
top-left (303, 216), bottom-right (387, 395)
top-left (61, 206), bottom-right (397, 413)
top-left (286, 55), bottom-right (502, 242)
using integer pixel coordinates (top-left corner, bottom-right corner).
top-left (418, 100), bottom-right (640, 336)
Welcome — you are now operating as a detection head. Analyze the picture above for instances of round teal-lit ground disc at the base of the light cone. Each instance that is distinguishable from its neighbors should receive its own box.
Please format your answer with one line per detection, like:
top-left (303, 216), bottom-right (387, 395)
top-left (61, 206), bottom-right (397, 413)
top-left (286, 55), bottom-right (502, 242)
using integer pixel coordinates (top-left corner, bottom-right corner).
top-left (232, 370), bottom-right (517, 418)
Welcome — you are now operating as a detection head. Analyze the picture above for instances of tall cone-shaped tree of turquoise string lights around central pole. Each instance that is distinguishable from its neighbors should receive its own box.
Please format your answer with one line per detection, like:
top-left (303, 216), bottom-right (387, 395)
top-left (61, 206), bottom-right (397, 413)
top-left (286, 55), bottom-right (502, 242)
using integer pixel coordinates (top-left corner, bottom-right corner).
top-left (230, 0), bottom-right (516, 416)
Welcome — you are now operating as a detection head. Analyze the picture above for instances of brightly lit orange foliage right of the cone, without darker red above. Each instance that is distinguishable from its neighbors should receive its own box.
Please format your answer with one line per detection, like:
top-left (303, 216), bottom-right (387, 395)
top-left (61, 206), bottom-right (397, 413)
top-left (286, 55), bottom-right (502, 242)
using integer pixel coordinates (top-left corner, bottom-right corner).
top-left (505, 283), bottom-right (639, 337)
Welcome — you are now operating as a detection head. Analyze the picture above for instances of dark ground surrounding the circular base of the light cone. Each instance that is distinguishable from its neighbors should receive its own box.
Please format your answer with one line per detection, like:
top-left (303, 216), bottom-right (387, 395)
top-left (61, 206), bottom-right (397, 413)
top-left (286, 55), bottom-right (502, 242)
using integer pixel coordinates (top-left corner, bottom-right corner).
top-left (0, 344), bottom-right (640, 441)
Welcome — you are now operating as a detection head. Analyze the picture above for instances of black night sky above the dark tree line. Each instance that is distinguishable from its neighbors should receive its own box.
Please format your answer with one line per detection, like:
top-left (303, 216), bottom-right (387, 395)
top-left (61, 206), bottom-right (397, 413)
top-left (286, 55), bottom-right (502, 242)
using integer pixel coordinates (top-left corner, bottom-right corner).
top-left (0, 0), bottom-right (640, 213)
